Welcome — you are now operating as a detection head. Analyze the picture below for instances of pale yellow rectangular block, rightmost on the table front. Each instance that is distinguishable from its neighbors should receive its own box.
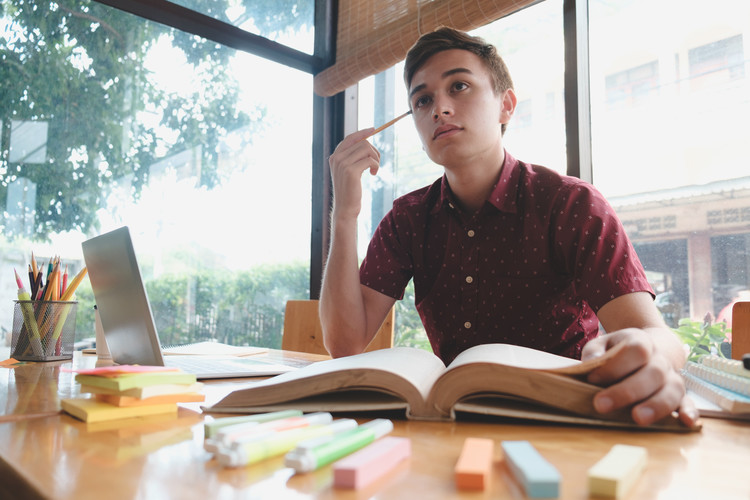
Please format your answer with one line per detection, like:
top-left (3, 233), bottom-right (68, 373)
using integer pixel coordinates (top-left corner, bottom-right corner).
top-left (588, 444), bottom-right (648, 498)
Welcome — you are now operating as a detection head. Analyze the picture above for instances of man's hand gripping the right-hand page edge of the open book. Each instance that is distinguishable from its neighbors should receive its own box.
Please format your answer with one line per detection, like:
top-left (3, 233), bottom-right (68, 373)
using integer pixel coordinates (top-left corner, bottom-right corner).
top-left (582, 328), bottom-right (698, 427)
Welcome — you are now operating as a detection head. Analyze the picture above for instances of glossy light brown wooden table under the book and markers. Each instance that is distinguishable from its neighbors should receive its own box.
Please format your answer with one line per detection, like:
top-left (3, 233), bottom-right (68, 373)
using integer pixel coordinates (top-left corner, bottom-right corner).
top-left (0, 351), bottom-right (750, 500)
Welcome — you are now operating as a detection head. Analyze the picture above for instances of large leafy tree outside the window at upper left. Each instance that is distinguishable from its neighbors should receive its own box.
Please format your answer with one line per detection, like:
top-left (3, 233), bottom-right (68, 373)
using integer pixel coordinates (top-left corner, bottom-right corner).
top-left (0, 0), bottom-right (312, 239)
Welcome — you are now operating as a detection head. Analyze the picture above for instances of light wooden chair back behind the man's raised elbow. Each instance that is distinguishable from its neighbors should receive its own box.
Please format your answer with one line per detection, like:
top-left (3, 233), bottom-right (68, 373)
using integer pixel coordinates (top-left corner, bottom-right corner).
top-left (281, 300), bottom-right (396, 354)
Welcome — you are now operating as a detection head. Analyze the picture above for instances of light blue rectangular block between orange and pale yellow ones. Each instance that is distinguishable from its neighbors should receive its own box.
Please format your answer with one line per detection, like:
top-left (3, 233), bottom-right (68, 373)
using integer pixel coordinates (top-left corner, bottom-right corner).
top-left (500, 441), bottom-right (560, 498)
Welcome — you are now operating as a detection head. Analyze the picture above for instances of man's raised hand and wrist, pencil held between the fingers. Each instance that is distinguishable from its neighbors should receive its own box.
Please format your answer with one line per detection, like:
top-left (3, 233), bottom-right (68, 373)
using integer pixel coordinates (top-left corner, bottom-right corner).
top-left (328, 127), bottom-right (380, 219)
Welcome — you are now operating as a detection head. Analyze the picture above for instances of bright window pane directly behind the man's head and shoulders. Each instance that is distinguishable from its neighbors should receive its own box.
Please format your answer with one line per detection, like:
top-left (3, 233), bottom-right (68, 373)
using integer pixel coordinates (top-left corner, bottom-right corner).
top-left (358, 0), bottom-right (567, 347)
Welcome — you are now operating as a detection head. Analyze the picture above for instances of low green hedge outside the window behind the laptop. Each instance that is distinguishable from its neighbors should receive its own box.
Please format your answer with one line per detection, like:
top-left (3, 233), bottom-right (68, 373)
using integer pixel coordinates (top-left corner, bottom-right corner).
top-left (76, 262), bottom-right (310, 349)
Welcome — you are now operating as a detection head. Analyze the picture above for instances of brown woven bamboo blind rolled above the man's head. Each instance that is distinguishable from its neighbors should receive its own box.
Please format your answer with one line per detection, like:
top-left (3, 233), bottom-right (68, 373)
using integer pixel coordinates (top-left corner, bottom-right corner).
top-left (313, 0), bottom-right (539, 97)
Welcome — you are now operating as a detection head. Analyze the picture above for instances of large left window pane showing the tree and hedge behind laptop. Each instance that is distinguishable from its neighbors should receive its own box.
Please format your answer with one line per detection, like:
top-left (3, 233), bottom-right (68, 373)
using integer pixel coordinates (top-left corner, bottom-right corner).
top-left (0, 0), bottom-right (312, 347)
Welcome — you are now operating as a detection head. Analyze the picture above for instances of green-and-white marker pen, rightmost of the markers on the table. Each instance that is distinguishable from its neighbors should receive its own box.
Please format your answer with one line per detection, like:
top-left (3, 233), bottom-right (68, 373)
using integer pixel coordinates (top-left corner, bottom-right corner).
top-left (284, 418), bottom-right (393, 472)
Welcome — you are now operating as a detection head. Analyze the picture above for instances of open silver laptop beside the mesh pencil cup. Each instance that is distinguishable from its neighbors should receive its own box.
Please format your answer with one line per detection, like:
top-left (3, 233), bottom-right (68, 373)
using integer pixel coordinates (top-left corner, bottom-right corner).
top-left (81, 226), bottom-right (295, 379)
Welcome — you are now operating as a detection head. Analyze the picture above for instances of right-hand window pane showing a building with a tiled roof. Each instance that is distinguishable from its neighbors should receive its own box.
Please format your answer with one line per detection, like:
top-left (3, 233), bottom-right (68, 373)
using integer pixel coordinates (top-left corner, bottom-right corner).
top-left (590, 0), bottom-right (750, 325)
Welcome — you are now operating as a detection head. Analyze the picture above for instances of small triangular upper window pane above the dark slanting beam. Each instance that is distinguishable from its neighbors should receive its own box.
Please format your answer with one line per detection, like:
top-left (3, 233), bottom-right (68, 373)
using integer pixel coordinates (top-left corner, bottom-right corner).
top-left (166, 0), bottom-right (315, 54)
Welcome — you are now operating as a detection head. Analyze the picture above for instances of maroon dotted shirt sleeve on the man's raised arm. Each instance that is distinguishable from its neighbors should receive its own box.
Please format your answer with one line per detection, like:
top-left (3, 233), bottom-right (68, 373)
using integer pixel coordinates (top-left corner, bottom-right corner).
top-left (359, 207), bottom-right (413, 300)
